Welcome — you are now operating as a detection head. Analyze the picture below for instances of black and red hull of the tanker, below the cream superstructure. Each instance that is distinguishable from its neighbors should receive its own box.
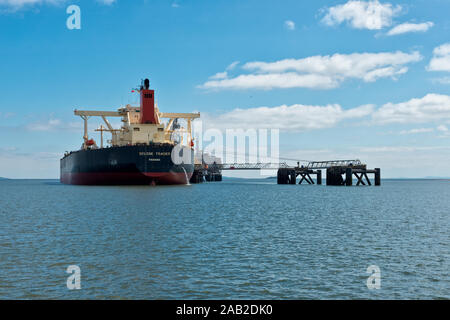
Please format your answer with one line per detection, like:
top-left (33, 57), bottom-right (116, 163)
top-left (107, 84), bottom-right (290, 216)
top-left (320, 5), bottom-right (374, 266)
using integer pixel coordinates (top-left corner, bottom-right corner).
top-left (60, 144), bottom-right (194, 185)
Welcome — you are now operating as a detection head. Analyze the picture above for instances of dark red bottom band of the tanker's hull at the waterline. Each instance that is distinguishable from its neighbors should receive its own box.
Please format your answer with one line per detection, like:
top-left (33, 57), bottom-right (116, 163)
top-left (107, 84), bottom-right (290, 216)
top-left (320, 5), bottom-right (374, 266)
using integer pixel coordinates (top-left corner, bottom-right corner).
top-left (60, 172), bottom-right (192, 185)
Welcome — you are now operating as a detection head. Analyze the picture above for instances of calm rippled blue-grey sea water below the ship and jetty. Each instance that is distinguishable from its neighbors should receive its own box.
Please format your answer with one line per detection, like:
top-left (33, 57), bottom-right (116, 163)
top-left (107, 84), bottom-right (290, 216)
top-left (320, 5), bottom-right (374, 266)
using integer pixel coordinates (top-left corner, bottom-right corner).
top-left (0, 180), bottom-right (450, 299)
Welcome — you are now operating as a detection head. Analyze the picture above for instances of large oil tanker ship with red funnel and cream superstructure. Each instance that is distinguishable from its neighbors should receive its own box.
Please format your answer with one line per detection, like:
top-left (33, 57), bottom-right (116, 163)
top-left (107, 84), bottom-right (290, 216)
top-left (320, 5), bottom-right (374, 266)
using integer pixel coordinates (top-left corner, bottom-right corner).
top-left (60, 79), bottom-right (200, 185)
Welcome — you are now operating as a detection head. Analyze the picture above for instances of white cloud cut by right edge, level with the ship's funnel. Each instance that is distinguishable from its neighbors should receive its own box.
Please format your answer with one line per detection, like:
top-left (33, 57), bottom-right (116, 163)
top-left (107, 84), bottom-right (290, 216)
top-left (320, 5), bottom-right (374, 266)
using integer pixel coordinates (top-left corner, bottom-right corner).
top-left (372, 93), bottom-right (450, 124)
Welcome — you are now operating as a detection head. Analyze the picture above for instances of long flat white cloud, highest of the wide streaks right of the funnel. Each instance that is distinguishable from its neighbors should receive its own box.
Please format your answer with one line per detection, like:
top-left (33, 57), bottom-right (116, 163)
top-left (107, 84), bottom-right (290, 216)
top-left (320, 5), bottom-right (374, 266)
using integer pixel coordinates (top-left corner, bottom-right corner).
top-left (199, 51), bottom-right (422, 90)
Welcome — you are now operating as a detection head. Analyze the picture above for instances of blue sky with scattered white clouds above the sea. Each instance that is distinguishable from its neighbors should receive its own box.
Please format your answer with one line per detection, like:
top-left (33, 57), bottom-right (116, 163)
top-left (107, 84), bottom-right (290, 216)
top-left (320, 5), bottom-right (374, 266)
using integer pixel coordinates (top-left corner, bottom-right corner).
top-left (0, 0), bottom-right (450, 178)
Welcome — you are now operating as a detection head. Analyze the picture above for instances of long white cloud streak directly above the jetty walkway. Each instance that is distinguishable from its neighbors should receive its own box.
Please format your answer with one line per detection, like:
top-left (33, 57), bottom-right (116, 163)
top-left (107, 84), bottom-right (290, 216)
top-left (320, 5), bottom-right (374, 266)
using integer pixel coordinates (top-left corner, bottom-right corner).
top-left (202, 104), bottom-right (373, 132)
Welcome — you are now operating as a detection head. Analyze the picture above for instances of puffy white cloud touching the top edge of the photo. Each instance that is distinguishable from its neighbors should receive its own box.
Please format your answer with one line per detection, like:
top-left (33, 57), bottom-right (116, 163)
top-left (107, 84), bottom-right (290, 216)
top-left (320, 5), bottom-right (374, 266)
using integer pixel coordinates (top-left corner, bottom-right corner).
top-left (322, 0), bottom-right (401, 30)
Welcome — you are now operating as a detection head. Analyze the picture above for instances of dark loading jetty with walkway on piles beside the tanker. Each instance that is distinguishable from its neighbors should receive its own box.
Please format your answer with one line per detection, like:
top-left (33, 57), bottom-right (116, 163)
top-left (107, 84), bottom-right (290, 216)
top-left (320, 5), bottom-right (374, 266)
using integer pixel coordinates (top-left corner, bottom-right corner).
top-left (190, 160), bottom-right (381, 186)
